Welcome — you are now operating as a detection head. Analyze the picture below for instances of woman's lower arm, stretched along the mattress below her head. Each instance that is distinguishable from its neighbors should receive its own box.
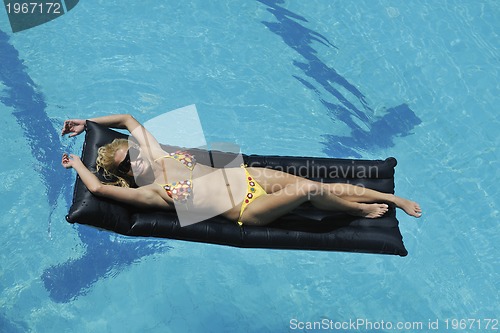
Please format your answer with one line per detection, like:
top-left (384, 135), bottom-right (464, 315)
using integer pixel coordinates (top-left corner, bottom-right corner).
top-left (62, 154), bottom-right (170, 209)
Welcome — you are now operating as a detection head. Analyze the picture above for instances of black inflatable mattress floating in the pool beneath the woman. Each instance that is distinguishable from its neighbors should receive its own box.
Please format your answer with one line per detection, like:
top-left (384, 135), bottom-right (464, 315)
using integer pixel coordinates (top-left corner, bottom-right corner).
top-left (66, 121), bottom-right (408, 256)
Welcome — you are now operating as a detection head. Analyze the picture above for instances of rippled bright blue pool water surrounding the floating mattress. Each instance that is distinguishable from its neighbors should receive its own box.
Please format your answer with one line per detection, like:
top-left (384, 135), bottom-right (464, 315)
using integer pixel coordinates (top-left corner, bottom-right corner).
top-left (0, 0), bottom-right (500, 333)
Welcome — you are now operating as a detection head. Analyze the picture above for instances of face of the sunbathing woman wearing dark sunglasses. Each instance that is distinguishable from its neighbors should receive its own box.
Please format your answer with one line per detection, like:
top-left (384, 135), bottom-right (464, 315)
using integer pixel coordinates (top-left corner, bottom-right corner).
top-left (115, 146), bottom-right (151, 178)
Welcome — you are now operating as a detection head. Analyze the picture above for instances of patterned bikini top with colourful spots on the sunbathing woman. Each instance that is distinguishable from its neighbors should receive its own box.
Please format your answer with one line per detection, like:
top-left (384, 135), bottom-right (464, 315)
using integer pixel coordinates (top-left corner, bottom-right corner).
top-left (155, 150), bottom-right (196, 203)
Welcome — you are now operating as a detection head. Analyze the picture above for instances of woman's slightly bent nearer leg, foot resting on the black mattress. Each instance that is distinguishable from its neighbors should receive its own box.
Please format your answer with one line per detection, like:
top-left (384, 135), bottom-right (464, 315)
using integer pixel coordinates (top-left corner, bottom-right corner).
top-left (241, 179), bottom-right (388, 225)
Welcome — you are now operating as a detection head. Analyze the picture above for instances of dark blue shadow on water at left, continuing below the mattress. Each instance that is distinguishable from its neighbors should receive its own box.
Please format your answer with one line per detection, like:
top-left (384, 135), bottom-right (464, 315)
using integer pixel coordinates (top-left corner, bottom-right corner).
top-left (0, 30), bottom-right (168, 302)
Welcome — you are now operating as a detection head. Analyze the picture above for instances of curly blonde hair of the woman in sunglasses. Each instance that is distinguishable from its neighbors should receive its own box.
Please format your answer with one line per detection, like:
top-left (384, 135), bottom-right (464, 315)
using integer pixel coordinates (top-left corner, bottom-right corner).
top-left (96, 139), bottom-right (130, 187)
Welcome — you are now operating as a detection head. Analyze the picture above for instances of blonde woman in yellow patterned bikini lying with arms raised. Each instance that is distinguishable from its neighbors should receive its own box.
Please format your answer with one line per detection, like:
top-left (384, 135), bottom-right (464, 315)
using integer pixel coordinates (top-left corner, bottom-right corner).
top-left (62, 115), bottom-right (422, 225)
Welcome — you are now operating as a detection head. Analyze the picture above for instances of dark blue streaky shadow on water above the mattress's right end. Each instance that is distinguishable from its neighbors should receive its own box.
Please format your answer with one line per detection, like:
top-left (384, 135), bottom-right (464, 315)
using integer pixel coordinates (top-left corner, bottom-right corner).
top-left (257, 0), bottom-right (421, 158)
